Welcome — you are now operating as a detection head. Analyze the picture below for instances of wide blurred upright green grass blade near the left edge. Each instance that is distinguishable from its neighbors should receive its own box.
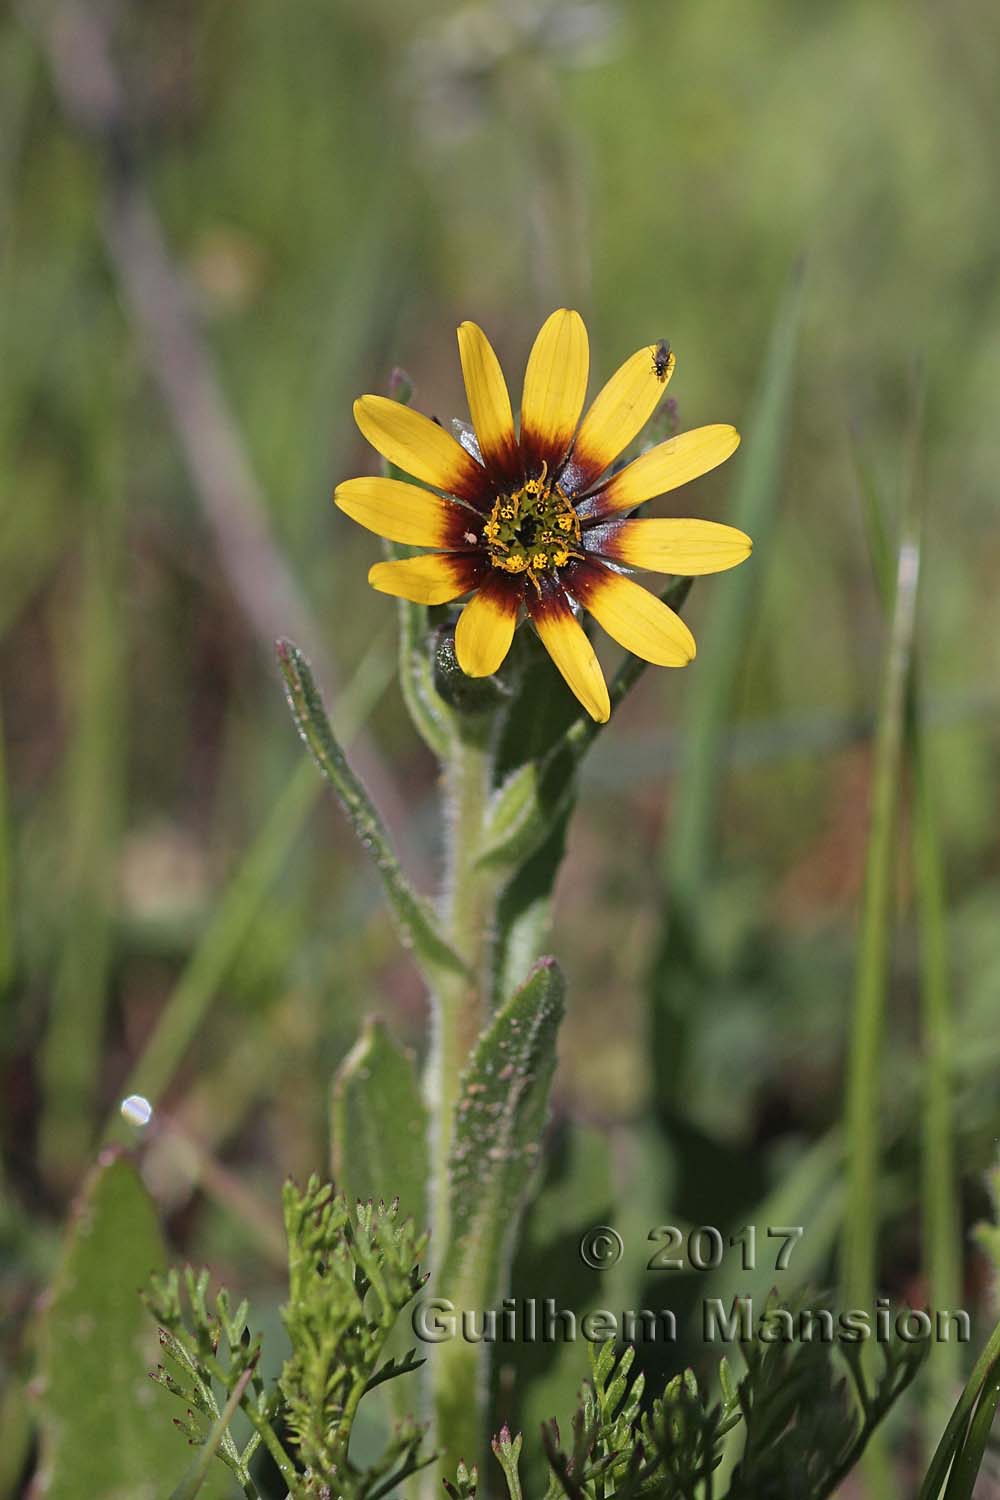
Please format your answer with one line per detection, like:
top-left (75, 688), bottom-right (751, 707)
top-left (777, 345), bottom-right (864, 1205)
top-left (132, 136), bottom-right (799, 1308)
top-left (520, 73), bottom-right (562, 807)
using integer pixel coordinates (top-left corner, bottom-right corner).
top-left (39, 443), bottom-right (124, 1188)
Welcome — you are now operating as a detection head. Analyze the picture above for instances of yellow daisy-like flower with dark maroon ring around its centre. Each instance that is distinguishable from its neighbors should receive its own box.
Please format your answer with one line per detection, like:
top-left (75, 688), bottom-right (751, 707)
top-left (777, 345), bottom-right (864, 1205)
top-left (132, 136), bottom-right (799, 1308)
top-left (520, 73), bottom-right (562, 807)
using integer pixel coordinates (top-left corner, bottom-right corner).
top-left (334, 308), bottom-right (751, 723)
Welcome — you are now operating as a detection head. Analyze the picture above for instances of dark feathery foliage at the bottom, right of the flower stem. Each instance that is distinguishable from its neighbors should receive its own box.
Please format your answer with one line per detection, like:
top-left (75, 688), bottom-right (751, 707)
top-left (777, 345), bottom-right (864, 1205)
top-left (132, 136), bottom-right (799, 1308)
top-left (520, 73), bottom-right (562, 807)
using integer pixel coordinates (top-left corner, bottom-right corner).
top-left (491, 1299), bottom-right (928, 1500)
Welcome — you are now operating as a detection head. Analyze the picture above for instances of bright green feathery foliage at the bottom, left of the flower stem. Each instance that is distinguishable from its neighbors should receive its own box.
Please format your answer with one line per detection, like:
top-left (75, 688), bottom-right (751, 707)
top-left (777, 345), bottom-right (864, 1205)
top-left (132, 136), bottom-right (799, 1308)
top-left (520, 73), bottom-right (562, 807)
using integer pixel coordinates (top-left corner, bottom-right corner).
top-left (145, 1176), bottom-right (434, 1500)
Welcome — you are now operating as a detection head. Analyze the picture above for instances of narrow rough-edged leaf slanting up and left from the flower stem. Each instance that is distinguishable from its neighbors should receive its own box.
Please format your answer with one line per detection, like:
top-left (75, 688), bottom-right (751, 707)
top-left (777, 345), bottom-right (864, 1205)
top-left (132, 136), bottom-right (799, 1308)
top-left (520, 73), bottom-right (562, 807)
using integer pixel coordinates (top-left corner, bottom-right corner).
top-left (277, 641), bottom-right (466, 975)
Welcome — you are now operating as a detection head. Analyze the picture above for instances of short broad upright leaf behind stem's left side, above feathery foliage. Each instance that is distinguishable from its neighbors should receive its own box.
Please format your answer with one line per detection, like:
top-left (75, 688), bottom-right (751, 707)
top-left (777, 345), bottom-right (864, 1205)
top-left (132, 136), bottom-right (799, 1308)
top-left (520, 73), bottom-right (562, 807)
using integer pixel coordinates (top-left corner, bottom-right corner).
top-left (331, 1017), bottom-right (429, 1229)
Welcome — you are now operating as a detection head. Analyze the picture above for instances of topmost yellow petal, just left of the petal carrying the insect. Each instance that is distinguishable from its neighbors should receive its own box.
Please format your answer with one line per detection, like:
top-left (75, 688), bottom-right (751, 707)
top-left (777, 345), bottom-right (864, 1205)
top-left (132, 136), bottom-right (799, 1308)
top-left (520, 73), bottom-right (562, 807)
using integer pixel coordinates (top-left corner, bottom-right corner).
top-left (520, 308), bottom-right (591, 470)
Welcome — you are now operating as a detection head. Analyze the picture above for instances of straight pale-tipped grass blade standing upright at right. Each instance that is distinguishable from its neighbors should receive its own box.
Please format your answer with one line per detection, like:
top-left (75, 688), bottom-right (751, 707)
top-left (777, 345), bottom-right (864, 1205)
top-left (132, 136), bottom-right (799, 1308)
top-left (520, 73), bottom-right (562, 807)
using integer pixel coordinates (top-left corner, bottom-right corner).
top-left (840, 390), bottom-right (921, 1496)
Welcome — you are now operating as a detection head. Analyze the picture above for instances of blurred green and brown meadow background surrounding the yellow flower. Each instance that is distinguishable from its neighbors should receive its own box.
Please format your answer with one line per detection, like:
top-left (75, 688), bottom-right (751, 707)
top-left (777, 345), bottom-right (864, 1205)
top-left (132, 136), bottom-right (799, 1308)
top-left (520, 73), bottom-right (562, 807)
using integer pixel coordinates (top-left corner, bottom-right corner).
top-left (0, 0), bottom-right (1000, 1494)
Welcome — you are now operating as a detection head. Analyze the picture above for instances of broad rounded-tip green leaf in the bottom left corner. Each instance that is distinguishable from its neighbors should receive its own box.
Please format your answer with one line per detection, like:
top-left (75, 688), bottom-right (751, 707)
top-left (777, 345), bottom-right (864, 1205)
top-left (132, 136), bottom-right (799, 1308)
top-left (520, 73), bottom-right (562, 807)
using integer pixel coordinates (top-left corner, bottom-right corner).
top-left (39, 1152), bottom-right (209, 1500)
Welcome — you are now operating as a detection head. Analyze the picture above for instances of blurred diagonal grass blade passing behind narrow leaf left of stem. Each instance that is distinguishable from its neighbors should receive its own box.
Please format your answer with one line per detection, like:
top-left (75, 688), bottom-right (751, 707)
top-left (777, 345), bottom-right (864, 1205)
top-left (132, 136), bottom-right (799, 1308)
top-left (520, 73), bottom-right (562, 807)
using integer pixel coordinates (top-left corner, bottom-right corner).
top-left (105, 638), bottom-right (393, 1140)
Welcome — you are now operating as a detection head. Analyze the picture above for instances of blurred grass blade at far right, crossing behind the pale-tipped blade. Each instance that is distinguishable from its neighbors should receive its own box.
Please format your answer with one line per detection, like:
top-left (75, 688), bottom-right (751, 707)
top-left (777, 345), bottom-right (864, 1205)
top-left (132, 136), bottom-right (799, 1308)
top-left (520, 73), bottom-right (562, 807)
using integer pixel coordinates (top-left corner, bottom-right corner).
top-left (855, 402), bottom-right (961, 1451)
